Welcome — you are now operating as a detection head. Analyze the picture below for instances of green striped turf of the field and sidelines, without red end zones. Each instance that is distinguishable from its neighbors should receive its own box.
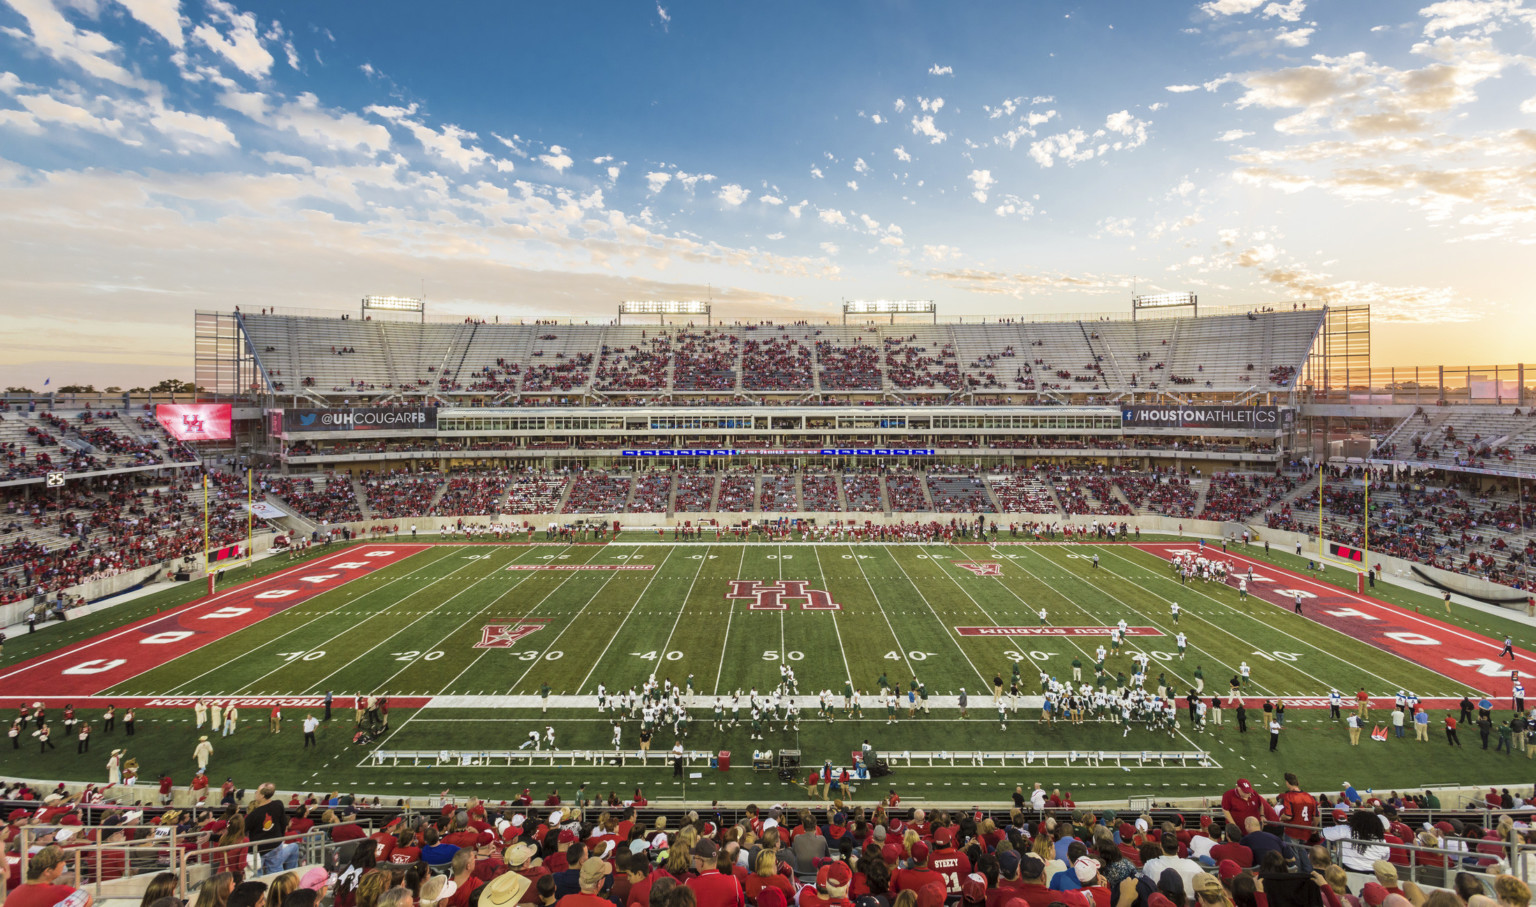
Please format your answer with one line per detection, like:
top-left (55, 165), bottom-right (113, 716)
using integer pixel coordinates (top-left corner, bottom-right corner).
top-left (0, 535), bottom-right (1531, 801)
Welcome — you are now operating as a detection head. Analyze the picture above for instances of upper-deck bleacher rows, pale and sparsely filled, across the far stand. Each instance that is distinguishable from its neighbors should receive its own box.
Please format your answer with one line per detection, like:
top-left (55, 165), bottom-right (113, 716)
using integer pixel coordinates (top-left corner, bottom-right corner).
top-left (241, 309), bottom-right (1322, 404)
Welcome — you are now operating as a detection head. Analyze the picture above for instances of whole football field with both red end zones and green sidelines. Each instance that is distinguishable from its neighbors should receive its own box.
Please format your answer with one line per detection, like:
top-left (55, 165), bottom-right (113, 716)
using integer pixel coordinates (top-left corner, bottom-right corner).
top-left (0, 540), bottom-right (1536, 799)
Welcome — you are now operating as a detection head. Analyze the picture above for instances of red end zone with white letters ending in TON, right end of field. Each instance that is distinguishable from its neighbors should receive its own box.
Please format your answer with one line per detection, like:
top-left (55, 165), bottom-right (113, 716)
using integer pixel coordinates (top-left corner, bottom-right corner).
top-left (1135, 543), bottom-right (1536, 707)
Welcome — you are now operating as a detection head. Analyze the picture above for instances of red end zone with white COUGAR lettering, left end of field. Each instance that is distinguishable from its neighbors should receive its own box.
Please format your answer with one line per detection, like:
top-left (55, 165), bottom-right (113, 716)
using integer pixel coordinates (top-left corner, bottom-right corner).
top-left (0, 544), bottom-right (430, 707)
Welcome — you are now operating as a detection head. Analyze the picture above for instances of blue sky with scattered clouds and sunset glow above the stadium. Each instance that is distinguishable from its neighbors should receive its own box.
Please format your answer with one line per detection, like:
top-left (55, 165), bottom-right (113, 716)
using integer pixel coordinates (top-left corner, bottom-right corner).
top-left (0, 0), bottom-right (1536, 387)
